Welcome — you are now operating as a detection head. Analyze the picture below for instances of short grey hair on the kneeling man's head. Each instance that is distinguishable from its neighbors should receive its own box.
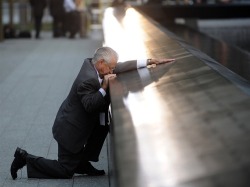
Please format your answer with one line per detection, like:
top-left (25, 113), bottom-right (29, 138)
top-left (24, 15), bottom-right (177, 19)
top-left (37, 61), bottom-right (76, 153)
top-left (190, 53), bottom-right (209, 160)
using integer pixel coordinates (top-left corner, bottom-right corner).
top-left (92, 47), bottom-right (118, 64)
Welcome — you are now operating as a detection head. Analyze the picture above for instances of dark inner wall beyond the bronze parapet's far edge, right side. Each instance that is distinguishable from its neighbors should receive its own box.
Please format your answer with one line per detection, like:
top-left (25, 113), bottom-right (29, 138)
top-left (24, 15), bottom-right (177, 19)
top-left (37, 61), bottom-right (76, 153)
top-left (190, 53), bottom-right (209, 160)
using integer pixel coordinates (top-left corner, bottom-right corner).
top-left (160, 25), bottom-right (250, 81)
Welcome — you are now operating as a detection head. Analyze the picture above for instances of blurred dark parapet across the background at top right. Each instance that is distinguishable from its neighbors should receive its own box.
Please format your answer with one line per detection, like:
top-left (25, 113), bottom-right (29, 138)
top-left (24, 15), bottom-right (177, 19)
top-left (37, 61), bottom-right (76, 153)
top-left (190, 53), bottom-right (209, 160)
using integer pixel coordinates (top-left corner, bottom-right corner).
top-left (136, 3), bottom-right (250, 23)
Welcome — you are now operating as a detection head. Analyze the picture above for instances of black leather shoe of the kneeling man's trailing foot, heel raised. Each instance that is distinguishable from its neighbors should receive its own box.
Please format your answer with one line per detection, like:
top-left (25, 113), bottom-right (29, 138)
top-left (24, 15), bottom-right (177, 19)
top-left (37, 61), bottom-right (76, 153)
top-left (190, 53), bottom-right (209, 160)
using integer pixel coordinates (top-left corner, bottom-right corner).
top-left (10, 147), bottom-right (28, 180)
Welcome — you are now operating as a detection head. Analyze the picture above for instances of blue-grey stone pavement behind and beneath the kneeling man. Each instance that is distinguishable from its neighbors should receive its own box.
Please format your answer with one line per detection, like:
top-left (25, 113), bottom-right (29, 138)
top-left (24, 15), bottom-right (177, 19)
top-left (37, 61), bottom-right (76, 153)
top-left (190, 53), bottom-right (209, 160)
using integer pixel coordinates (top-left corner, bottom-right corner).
top-left (0, 30), bottom-right (109, 187)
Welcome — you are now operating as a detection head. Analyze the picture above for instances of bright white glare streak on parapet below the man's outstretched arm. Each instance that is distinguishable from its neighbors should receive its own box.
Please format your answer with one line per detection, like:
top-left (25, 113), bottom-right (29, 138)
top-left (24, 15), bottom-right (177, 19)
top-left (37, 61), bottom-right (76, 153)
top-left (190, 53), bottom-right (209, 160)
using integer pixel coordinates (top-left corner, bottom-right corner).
top-left (123, 83), bottom-right (180, 186)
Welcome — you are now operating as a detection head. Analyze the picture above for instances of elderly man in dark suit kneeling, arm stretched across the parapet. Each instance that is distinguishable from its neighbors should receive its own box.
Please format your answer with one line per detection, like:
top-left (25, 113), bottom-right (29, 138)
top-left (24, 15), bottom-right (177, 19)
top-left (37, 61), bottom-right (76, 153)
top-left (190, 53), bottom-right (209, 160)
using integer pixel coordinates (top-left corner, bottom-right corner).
top-left (10, 47), bottom-right (174, 179)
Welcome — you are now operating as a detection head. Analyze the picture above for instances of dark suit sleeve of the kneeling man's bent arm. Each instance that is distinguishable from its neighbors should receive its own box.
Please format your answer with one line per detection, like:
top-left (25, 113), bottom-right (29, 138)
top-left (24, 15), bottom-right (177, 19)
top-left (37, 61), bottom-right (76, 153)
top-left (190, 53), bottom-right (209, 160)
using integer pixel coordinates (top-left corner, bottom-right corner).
top-left (77, 79), bottom-right (107, 113)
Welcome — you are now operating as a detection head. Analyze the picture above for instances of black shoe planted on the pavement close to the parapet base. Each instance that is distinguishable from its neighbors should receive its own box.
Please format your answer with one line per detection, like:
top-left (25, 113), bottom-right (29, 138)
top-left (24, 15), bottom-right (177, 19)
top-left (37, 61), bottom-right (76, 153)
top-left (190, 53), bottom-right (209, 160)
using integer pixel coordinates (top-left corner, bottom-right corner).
top-left (76, 162), bottom-right (105, 176)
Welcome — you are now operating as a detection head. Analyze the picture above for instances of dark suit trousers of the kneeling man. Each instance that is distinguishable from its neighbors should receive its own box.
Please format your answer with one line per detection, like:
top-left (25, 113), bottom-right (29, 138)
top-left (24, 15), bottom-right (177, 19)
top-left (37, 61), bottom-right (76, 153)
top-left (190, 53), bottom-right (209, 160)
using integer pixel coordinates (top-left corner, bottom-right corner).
top-left (26, 125), bottom-right (109, 179)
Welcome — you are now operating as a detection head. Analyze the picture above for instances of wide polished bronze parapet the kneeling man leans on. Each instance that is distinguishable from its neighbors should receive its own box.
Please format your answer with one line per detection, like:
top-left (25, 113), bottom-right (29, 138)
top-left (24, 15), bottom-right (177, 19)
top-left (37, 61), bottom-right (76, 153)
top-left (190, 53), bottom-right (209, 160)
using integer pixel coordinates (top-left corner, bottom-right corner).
top-left (103, 5), bottom-right (250, 187)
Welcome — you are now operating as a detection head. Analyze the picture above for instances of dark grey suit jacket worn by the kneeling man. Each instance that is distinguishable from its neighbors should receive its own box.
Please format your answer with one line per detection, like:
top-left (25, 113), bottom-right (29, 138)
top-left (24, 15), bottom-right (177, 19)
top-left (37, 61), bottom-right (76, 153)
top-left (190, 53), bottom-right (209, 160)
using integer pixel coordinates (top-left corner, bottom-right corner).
top-left (52, 59), bottom-right (137, 153)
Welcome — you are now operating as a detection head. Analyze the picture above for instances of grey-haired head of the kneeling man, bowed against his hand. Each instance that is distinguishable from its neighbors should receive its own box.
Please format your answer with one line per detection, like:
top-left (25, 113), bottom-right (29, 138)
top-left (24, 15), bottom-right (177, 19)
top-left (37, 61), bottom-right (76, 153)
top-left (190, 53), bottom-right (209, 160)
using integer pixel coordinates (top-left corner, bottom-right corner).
top-left (92, 47), bottom-right (118, 78)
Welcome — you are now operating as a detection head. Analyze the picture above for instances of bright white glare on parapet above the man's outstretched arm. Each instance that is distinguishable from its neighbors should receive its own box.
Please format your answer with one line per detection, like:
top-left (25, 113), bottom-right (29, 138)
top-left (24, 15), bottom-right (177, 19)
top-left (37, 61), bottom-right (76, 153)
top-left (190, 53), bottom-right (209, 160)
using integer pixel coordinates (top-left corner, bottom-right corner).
top-left (103, 8), bottom-right (147, 61)
